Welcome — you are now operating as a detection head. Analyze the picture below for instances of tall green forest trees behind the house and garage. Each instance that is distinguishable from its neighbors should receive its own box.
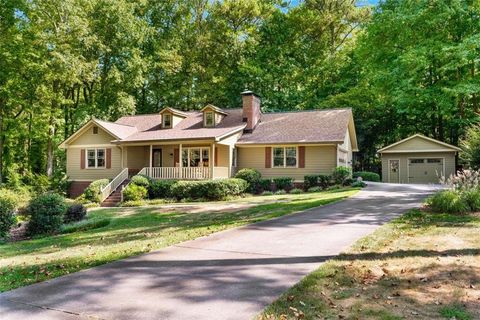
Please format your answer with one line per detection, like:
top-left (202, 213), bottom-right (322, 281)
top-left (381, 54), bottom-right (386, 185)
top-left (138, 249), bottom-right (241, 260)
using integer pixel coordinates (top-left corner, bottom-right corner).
top-left (0, 0), bottom-right (480, 188)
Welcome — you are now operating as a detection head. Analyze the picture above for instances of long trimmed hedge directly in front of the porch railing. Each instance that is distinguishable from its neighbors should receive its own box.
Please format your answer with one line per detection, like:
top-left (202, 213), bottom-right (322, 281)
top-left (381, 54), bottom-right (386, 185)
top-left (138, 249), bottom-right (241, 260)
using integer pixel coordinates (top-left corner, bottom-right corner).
top-left (171, 178), bottom-right (248, 200)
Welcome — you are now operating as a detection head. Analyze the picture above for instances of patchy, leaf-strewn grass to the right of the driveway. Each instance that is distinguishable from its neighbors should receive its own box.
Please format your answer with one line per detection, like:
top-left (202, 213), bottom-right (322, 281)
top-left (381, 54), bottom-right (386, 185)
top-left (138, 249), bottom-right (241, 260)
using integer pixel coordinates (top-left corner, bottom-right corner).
top-left (259, 210), bottom-right (480, 320)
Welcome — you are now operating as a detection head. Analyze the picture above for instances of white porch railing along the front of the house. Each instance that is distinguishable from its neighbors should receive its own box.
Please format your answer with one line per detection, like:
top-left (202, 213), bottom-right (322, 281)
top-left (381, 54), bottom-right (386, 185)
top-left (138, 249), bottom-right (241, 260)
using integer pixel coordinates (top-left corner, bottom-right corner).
top-left (138, 167), bottom-right (228, 180)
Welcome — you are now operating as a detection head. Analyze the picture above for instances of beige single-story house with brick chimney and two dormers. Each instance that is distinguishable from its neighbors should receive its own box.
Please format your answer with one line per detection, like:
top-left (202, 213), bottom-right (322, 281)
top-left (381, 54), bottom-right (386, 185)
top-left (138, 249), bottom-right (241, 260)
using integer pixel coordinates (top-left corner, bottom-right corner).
top-left (61, 91), bottom-right (357, 196)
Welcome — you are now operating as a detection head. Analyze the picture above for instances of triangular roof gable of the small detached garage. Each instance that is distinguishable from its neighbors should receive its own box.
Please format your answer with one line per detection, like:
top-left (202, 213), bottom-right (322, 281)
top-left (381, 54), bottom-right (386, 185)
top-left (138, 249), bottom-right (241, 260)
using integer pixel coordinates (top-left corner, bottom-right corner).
top-left (378, 134), bottom-right (460, 153)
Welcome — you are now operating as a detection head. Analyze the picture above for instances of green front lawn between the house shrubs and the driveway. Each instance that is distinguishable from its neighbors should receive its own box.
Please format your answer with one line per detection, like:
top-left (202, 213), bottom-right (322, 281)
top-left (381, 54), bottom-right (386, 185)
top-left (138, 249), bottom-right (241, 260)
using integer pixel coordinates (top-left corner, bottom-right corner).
top-left (0, 189), bottom-right (358, 292)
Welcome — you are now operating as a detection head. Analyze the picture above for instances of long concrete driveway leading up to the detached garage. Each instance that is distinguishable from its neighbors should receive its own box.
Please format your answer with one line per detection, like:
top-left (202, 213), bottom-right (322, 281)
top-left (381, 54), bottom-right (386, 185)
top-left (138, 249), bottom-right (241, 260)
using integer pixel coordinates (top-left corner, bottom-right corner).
top-left (0, 183), bottom-right (433, 320)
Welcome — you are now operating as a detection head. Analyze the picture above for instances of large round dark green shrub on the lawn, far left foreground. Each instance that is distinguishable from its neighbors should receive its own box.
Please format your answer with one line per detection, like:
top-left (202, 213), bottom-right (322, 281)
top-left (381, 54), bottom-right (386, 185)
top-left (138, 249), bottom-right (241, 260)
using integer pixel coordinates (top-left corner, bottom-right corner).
top-left (27, 193), bottom-right (67, 235)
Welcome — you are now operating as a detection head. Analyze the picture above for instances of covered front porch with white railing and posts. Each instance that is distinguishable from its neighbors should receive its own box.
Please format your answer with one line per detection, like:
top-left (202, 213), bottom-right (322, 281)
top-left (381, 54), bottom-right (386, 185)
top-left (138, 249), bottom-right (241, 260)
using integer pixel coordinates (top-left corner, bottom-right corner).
top-left (121, 141), bottom-right (233, 180)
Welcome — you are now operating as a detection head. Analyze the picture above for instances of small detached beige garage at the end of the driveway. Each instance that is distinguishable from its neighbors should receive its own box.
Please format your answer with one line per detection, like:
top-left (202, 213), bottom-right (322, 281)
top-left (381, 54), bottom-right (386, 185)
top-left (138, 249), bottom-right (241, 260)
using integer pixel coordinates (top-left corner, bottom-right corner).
top-left (378, 134), bottom-right (460, 183)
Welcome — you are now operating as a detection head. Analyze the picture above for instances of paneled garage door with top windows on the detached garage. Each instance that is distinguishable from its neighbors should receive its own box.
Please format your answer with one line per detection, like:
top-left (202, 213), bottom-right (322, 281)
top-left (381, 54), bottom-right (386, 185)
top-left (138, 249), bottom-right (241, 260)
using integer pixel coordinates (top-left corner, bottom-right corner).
top-left (408, 158), bottom-right (444, 183)
